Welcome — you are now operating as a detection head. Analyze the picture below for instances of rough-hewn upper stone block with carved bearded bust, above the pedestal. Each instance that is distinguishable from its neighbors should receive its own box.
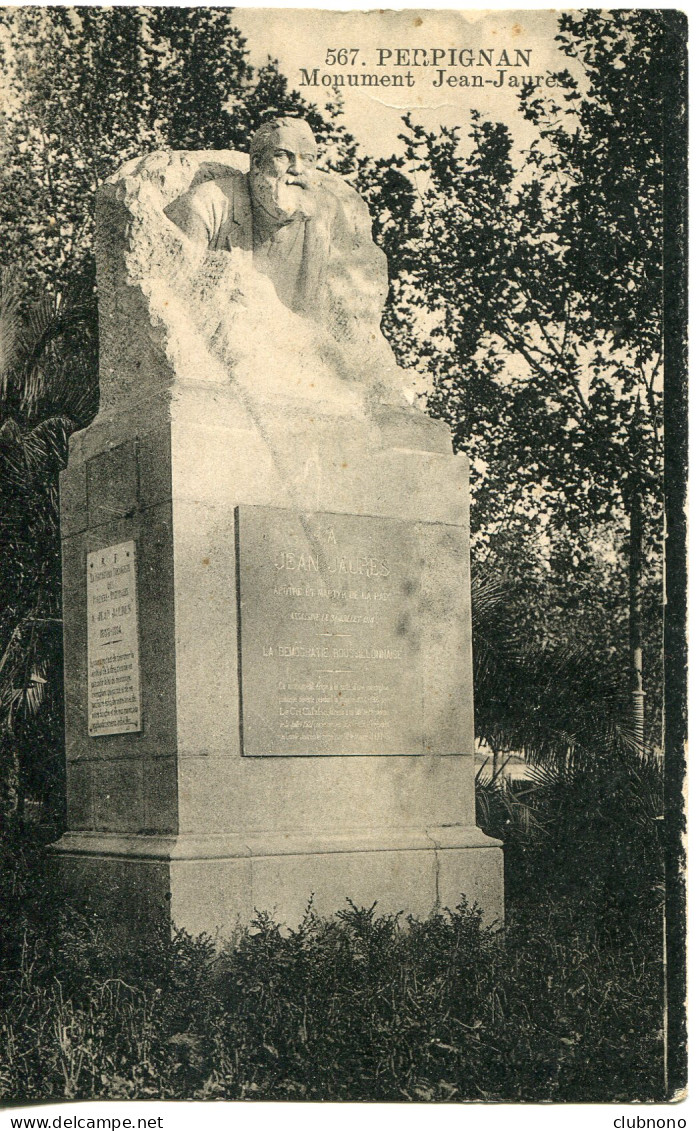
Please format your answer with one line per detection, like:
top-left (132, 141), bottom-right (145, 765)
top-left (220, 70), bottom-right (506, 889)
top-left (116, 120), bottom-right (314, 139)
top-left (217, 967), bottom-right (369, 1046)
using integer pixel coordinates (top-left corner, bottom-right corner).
top-left (96, 118), bottom-right (431, 424)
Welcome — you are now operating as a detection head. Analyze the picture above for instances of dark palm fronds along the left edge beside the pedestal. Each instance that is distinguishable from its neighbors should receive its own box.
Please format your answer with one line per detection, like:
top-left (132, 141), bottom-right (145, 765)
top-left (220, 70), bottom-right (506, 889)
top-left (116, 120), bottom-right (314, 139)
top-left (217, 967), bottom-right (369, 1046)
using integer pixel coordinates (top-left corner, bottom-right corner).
top-left (0, 273), bottom-right (96, 817)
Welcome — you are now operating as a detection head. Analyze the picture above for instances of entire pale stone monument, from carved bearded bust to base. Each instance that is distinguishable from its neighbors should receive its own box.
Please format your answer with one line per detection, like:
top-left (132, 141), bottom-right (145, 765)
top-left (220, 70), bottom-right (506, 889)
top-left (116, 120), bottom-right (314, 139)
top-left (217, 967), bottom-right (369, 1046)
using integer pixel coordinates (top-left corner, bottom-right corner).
top-left (54, 119), bottom-right (502, 934)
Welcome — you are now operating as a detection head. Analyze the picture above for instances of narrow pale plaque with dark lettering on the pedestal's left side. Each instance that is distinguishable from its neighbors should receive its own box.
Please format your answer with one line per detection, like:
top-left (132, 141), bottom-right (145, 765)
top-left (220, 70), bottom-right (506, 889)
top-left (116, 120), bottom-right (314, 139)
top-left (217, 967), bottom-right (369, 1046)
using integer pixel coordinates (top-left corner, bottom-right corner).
top-left (87, 542), bottom-right (141, 737)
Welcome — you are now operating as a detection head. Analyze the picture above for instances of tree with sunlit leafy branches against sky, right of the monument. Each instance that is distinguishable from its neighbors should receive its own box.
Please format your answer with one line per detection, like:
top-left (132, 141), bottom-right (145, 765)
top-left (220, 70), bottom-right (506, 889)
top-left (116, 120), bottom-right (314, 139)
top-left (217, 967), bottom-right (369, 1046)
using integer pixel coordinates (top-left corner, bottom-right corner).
top-left (362, 10), bottom-right (664, 750)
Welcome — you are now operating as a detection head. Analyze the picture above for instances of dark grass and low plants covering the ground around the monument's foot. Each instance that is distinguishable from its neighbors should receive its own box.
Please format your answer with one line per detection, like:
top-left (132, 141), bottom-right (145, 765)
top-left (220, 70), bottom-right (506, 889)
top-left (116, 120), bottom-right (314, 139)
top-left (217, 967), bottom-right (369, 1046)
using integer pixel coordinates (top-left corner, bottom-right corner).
top-left (0, 760), bottom-right (664, 1103)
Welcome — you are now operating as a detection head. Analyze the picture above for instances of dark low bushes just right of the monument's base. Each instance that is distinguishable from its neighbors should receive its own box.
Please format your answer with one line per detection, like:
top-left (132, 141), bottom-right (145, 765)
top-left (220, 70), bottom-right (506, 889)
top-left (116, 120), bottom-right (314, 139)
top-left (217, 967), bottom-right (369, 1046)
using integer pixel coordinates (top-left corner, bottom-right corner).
top-left (476, 750), bottom-right (664, 918)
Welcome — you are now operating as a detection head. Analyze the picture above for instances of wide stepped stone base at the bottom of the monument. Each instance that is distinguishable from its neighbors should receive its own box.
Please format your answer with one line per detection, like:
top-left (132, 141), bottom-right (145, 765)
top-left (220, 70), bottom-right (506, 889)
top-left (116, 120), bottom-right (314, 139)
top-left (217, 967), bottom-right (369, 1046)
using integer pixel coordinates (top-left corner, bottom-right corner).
top-left (53, 827), bottom-right (504, 941)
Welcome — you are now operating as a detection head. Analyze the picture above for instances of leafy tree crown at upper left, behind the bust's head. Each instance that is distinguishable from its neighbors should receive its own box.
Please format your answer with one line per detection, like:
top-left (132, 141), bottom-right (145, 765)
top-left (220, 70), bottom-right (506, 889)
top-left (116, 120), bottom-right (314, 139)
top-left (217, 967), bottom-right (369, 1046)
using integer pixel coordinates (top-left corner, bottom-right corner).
top-left (0, 6), bottom-right (355, 303)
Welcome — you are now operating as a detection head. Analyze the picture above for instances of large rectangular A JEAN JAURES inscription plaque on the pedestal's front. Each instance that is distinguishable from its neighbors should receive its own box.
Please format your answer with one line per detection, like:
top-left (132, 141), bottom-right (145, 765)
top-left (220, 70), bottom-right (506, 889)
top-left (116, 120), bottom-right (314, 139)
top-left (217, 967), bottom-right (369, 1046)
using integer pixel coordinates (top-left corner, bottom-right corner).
top-left (238, 506), bottom-right (423, 757)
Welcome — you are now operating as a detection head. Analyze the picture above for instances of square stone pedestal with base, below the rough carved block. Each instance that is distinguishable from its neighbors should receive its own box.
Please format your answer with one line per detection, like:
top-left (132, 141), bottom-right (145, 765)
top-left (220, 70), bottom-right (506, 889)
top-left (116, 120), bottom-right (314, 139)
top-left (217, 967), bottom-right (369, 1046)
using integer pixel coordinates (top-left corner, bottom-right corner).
top-left (55, 383), bottom-right (502, 933)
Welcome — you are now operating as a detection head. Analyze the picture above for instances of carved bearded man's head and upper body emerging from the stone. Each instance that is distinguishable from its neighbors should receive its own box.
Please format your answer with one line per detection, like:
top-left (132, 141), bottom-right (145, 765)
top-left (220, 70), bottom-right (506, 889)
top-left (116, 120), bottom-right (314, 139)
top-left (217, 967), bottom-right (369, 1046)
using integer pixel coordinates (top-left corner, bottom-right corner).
top-left (165, 118), bottom-right (387, 330)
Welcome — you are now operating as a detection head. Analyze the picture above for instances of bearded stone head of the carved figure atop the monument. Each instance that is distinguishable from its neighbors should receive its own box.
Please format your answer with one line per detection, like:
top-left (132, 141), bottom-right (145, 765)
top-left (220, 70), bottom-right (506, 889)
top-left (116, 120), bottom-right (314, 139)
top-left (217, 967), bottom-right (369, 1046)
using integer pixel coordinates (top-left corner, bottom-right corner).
top-left (250, 126), bottom-right (317, 223)
